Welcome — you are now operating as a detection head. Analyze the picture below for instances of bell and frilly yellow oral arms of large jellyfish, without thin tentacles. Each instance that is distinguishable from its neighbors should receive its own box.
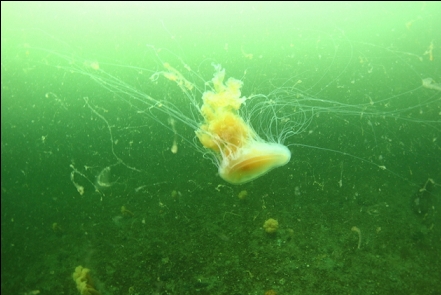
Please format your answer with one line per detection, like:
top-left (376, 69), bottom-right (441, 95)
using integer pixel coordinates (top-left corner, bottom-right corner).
top-left (196, 67), bottom-right (291, 184)
